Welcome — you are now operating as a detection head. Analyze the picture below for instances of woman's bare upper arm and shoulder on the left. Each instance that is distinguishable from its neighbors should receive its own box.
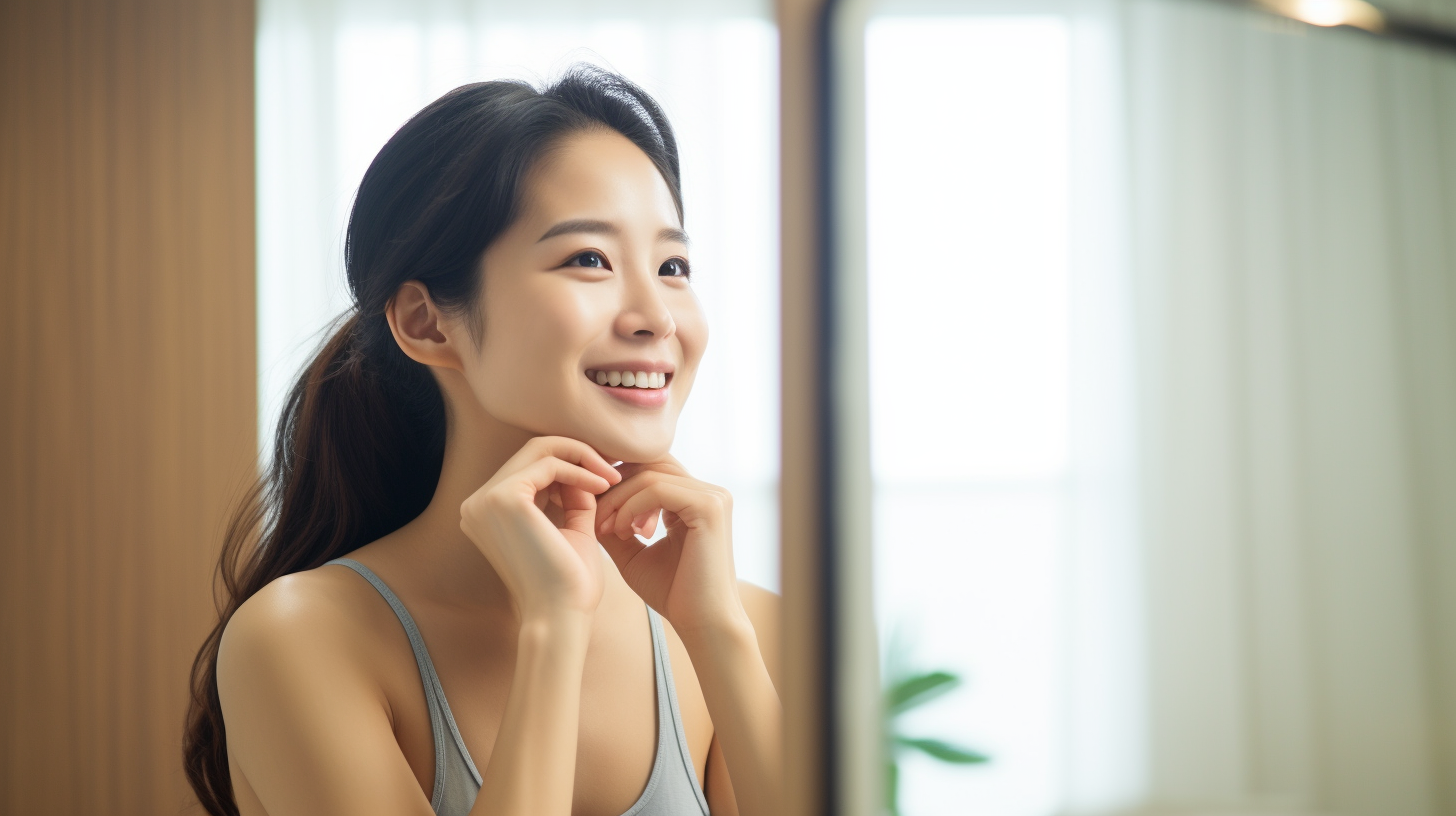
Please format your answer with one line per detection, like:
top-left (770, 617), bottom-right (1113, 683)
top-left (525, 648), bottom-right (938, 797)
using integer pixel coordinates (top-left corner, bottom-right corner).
top-left (217, 576), bottom-right (431, 816)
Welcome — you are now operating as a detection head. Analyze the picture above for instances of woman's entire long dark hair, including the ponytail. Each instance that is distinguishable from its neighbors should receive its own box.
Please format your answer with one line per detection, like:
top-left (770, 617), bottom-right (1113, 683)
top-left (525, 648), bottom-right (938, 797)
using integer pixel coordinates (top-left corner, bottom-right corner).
top-left (182, 66), bottom-right (683, 816)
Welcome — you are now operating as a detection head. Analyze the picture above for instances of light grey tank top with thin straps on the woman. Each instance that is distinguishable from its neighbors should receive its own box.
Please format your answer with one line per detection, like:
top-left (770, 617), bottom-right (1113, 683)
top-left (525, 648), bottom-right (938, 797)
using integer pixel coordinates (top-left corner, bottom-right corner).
top-left (329, 558), bottom-right (708, 816)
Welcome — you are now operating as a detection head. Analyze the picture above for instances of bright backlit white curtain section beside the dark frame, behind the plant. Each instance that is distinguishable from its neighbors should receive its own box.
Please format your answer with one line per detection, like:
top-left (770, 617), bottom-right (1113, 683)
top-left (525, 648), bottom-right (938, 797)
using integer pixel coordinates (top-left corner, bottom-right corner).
top-left (863, 9), bottom-right (1144, 816)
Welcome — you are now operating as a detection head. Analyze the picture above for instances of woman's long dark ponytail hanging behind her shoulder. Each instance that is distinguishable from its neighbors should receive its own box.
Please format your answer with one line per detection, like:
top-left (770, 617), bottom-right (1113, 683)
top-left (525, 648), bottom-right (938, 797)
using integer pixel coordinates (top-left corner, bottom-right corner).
top-left (182, 313), bottom-right (446, 816)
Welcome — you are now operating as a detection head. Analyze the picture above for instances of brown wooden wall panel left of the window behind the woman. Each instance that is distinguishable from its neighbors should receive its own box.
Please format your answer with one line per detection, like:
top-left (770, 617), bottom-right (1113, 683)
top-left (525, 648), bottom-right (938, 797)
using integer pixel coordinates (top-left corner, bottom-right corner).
top-left (0, 0), bottom-right (256, 815)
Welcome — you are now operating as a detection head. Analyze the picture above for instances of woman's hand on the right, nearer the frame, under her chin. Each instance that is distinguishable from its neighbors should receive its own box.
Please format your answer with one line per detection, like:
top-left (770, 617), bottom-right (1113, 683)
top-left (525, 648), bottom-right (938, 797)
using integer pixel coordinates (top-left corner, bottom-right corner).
top-left (597, 456), bottom-right (748, 638)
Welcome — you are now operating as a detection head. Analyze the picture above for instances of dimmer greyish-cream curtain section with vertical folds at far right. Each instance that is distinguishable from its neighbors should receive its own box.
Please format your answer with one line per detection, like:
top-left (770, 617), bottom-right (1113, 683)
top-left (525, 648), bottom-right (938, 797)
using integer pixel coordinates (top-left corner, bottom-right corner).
top-left (1123, 1), bottom-right (1456, 816)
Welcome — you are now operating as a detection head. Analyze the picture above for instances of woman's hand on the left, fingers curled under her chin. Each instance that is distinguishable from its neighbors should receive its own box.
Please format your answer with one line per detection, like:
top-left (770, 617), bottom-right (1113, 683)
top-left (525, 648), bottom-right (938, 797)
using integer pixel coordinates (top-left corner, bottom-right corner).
top-left (460, 436), bottom-right (622, 622)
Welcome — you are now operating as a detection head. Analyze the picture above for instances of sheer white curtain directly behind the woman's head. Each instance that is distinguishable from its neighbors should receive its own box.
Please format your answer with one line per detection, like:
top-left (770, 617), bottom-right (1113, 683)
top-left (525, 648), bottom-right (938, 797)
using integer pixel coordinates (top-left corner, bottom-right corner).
top-left (258, 0), bottom-right (779, 589)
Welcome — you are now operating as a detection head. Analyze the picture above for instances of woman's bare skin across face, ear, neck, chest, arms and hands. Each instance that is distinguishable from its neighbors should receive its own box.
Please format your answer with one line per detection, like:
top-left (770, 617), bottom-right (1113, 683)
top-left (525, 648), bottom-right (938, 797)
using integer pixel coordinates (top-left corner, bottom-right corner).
top-left (217, 130), bottom-right (783, 816)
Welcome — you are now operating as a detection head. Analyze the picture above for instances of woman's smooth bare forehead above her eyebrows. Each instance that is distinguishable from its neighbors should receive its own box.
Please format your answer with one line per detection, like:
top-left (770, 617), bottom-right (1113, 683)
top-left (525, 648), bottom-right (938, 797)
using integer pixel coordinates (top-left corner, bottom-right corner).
top-left (521, 128), bottom-right (681, 230)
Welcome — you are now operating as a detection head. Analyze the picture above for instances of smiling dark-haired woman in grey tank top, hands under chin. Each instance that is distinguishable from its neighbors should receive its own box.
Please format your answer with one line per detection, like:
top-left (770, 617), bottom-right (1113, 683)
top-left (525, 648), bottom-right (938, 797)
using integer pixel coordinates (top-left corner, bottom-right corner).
top-left (185, 67), bottom-right (782, 816)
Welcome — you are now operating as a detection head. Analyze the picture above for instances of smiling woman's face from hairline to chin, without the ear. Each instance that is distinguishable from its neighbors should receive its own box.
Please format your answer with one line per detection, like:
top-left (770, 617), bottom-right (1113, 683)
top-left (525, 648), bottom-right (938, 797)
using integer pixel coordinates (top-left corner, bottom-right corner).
top-left (464, 128), bottom-right (708, 462)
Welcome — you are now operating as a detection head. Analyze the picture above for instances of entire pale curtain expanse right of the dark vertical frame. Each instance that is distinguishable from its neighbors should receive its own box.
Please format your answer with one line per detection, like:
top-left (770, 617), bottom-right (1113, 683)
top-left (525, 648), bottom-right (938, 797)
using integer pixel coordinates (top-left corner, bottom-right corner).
top-left (865, 0), bottom-right (1456, 816)
